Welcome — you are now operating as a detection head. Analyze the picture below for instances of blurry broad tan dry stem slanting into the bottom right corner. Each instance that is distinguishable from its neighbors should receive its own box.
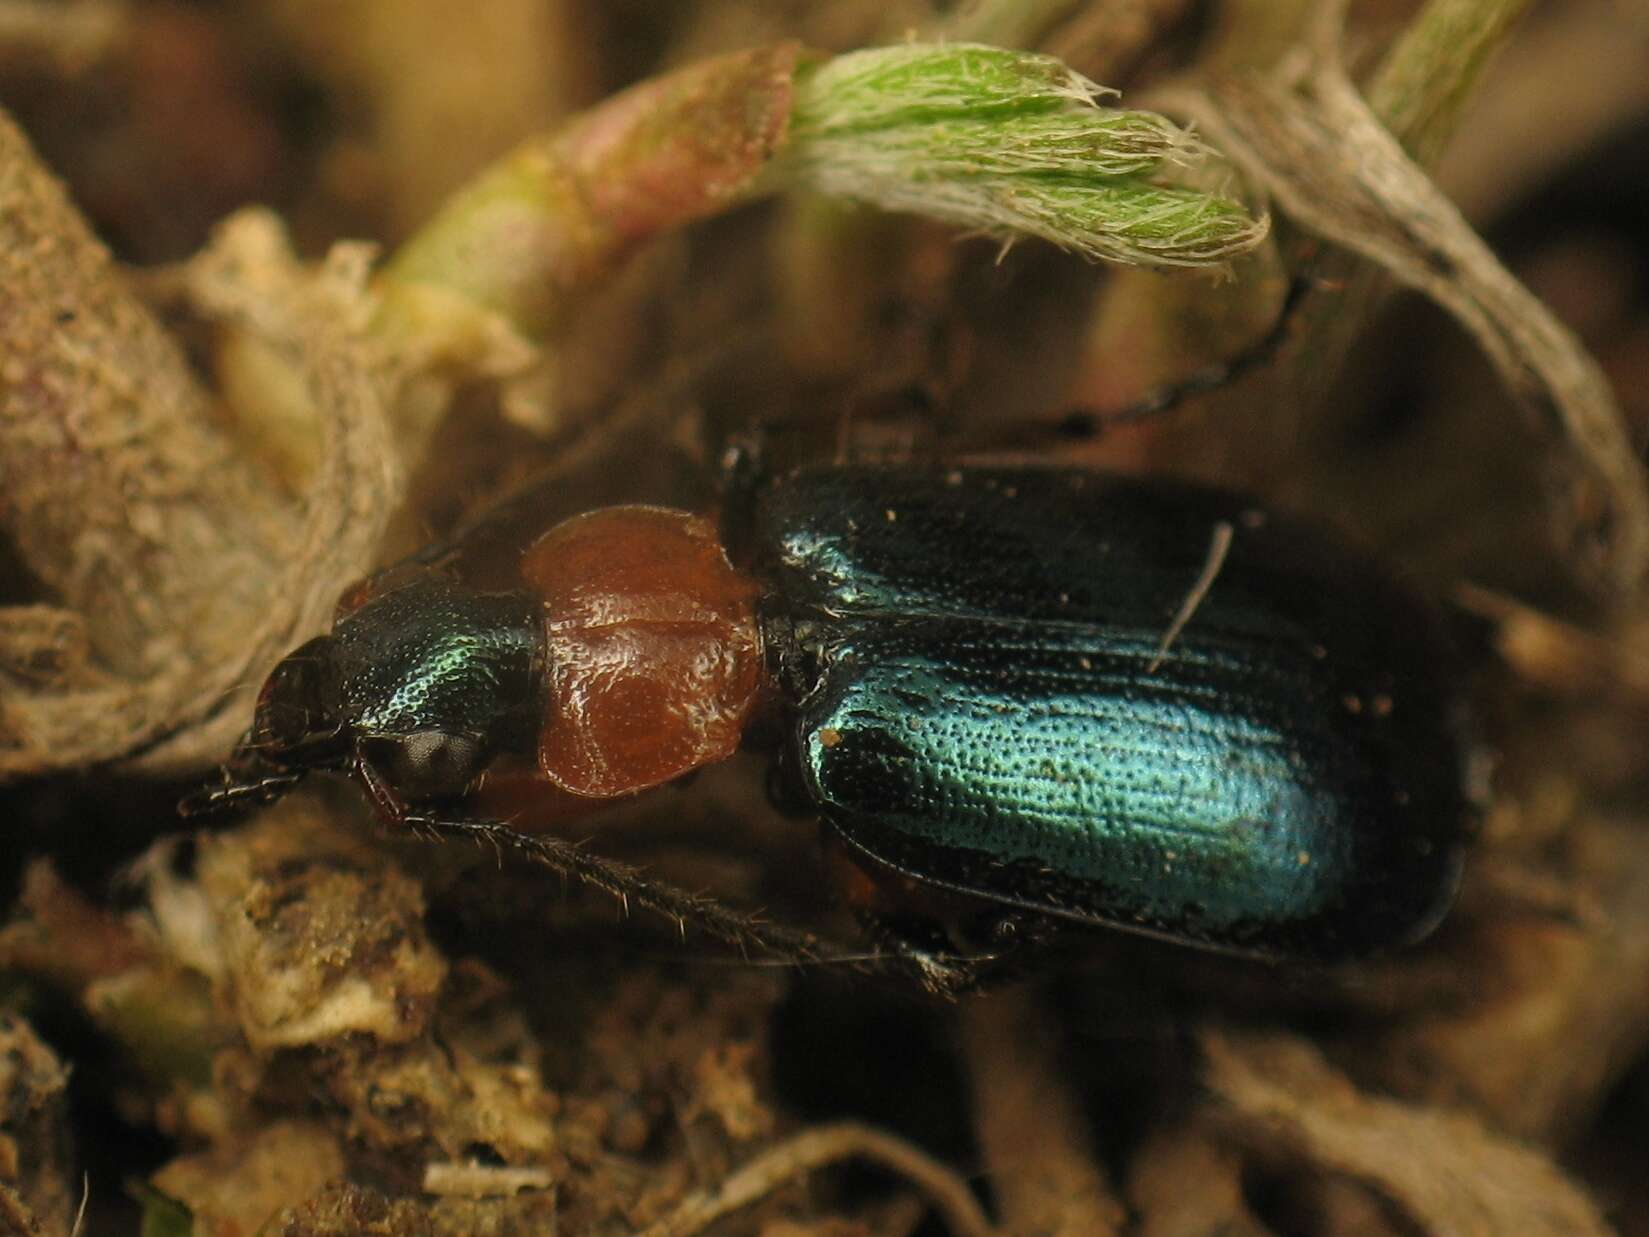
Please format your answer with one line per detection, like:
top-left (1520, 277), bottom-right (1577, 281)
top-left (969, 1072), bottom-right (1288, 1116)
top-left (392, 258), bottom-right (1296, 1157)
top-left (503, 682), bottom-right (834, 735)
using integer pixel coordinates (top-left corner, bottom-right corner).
top-left (1204, 1034), bottom-right (1611, 1237)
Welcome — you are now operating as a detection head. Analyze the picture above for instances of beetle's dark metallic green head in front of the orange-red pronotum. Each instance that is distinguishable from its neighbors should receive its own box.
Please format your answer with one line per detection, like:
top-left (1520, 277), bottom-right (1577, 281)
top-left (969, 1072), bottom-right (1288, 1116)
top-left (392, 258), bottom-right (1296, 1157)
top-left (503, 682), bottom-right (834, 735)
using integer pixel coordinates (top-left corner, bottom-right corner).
top-left (193, 576), bottom-right (544, 808)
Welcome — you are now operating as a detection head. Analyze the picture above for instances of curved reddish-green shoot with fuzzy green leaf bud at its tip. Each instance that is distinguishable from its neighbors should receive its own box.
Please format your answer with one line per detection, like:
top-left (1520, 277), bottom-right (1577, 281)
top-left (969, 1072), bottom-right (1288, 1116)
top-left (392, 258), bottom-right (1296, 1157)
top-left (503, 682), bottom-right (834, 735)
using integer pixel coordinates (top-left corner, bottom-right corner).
top-left (379, 43), bottom-right (1266, 365)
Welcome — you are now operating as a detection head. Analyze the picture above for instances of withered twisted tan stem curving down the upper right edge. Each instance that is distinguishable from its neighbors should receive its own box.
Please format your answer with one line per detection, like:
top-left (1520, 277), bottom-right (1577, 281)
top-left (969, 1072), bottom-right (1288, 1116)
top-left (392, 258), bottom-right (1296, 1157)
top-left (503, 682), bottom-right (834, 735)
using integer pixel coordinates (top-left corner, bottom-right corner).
top-left (1169, 3), bottom-right (1649, 595)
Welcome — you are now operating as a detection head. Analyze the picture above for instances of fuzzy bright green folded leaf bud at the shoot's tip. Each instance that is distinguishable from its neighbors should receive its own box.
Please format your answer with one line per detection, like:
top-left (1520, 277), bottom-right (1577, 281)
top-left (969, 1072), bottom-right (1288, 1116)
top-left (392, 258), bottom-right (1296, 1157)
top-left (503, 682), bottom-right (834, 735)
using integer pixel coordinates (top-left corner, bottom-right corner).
top-left (783, 43), bottom-right (1266, 266)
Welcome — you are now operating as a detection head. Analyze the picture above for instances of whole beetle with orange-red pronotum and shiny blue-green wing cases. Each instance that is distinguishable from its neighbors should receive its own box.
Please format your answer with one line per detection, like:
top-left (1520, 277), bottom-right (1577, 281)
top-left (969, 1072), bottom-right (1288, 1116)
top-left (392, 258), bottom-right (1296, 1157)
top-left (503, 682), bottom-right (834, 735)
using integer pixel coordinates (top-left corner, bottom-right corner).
top-left (187, 463), bottom-right (1471, 988)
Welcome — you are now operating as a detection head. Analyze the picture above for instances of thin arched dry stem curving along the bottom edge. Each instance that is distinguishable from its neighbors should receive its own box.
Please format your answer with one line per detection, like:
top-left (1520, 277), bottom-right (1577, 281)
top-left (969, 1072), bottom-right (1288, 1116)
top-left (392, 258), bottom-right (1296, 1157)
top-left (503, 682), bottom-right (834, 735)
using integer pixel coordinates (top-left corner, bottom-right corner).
top-left (643, 1122), bottom-right (996, 1237)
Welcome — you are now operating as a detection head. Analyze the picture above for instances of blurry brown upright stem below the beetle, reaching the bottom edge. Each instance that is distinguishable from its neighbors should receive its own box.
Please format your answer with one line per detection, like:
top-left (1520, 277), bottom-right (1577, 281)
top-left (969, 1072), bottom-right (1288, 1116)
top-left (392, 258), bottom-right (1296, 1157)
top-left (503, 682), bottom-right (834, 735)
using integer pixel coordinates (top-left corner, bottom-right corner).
top-left (961, 988), bottom-right (1126, 1237)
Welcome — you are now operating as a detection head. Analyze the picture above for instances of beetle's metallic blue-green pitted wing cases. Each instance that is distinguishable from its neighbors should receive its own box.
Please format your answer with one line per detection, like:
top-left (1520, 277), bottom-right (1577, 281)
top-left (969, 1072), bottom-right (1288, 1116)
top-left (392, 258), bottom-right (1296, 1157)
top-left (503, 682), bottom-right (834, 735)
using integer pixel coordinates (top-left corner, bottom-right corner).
top-left (750, 467), bottom-right (1469, 962)
